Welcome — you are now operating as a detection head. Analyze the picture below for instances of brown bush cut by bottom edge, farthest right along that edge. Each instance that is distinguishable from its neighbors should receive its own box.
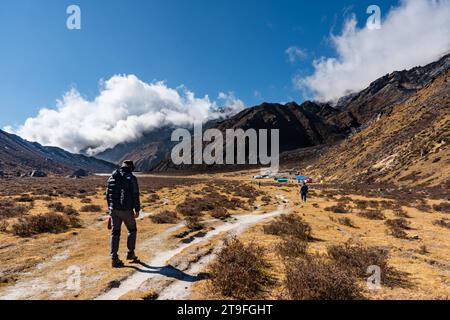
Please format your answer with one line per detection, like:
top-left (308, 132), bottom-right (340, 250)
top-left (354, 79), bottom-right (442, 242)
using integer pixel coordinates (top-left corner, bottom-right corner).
top-left (284, 256), bottom-right (361, 300)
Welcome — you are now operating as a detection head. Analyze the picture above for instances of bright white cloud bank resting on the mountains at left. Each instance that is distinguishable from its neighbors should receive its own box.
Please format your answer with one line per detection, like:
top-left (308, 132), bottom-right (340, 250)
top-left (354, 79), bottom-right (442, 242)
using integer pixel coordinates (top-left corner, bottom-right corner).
top-left (5, 75), bottom-right (244, 155)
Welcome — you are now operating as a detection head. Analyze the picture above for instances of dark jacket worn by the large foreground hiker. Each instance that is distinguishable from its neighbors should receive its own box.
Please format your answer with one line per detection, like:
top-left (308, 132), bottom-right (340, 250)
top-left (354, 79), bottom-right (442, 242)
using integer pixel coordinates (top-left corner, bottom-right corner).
top-left (106, 168), bottom-right (141, 212)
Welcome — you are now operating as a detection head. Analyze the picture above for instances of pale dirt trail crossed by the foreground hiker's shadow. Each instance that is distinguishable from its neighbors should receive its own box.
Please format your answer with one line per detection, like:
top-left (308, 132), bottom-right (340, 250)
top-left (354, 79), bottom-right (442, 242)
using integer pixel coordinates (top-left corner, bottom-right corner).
top-left (96, 200), bottom-right (287, 300)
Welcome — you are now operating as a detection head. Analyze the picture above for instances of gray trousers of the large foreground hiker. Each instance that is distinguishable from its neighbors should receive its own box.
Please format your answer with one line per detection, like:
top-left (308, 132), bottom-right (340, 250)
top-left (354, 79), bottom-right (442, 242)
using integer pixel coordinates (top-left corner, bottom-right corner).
top-left (111, 210), bottom-right (137, 257)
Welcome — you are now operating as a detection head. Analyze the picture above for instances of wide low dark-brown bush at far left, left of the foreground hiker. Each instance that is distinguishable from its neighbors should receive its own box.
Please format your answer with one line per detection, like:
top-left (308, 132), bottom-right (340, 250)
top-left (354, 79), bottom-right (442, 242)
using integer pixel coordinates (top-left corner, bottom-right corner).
top-left (12, 213), bottom-right (71, 237)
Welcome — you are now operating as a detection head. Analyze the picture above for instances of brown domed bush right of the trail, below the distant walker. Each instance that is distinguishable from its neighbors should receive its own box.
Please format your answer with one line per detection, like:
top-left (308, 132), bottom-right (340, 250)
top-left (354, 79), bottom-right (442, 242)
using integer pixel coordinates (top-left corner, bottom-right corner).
top-left (263, 214), bottom-right (312, 241)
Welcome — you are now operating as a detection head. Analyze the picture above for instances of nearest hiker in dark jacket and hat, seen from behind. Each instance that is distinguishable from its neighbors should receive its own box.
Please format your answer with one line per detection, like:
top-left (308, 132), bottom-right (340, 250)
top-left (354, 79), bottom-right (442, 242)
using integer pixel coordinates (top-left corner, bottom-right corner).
top-left (106, 160), bottom-right (141, 268)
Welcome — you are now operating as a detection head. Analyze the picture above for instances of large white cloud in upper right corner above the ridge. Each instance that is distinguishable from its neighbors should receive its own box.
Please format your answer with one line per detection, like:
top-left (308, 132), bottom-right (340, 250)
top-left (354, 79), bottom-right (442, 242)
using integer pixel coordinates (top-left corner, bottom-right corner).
top-left (294, 0), bottom-right (450, 100)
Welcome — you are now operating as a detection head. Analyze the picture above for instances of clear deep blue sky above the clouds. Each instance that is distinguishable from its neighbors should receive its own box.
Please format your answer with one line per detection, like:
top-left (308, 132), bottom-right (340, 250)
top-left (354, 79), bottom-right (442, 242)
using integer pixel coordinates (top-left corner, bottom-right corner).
top-left (0, 0), bottom-right (397, 127)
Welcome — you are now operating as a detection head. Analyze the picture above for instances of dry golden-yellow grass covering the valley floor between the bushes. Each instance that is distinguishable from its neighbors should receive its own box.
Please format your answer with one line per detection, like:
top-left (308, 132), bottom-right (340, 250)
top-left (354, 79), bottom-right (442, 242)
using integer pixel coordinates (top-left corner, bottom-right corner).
top-left (0, 172), bottom-right (450, 299)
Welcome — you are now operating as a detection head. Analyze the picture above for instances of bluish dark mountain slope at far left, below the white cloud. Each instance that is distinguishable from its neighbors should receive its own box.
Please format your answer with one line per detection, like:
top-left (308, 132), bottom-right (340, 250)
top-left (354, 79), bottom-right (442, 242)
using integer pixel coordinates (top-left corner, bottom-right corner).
top-left (0, 130), bottom-right (115, 175)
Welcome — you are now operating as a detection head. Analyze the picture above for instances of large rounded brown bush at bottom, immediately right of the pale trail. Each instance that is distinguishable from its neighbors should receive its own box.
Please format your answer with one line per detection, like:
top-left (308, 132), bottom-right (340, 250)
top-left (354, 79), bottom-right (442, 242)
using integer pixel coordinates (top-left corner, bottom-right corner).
top-left (209, 239), bottom-right (274, 300)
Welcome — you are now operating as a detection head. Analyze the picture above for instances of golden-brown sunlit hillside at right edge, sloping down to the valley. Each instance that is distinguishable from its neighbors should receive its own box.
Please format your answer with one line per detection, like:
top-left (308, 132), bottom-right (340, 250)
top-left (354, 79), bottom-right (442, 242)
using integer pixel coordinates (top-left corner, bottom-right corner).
top-left (313, 70), bottom-right (450, 188)
